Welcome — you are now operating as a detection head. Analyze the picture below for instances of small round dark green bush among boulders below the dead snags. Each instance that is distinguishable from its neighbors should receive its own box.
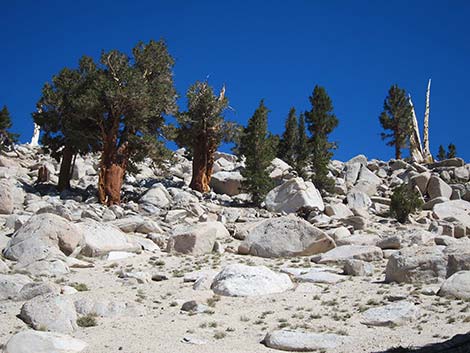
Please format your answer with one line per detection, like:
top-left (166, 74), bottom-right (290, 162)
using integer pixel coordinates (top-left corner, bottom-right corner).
top-left (390, 184), bottom-right (423, 223)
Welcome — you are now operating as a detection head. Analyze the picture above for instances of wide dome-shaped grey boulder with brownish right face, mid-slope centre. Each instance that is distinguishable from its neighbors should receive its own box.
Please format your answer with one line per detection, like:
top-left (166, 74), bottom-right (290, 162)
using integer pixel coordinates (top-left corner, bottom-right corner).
top-left (239, 216), bottom-right (335, 257)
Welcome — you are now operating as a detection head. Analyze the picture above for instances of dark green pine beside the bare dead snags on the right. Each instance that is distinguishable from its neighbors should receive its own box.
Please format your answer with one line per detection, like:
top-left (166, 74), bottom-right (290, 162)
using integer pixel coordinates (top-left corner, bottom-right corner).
top-left (379, 85), bottom-right (413, 159)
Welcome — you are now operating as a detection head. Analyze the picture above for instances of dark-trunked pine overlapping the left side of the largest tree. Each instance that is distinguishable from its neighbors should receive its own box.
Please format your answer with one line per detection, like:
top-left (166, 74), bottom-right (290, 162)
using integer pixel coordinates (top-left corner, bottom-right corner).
top-left (32, 56), bottom-right (99, 191)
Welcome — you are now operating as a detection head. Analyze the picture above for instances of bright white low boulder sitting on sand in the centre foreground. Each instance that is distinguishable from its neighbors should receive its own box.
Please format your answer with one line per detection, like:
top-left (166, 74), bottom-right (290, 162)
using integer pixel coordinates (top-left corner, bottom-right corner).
top-left (211, 264), bottom-right (293, 297)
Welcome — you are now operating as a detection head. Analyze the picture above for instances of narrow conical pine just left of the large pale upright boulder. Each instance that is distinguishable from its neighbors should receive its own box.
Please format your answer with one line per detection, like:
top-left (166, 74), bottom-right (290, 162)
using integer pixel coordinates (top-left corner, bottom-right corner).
top-left (238, 100), bottom-right (275, 205)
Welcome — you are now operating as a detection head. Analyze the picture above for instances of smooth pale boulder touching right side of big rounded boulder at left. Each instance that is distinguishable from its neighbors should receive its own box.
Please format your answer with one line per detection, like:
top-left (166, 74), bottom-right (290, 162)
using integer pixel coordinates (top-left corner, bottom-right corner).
top-left (77, 218), bottom-right (142, 257)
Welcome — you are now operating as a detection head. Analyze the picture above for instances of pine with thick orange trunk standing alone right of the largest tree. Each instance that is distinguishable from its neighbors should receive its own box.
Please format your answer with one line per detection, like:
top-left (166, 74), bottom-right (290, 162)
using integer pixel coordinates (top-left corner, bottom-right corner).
top-left (176, 82), bottom-right (229, 192)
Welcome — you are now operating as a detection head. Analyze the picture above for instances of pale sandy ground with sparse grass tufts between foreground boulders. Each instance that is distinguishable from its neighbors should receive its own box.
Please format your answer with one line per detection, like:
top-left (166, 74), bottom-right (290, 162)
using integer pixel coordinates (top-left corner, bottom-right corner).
top-left (0, 236), bottom-right (470, 353)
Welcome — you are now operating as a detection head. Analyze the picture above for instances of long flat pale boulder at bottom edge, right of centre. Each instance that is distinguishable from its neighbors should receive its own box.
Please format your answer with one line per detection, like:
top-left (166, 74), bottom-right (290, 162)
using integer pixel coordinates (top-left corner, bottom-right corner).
top-left (263, 330), bottom-right (346, 352)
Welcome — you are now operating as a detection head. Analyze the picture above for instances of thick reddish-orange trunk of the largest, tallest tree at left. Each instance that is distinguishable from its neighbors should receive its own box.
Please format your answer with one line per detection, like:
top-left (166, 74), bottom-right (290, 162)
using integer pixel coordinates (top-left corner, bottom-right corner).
top-left (98, 131), bottom-right (129, 206)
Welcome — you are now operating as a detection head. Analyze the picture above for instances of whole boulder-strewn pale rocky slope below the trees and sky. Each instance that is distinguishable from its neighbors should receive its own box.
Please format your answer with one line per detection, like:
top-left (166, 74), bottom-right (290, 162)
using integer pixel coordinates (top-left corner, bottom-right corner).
top-left (0, 145), bottom-right (470, 353)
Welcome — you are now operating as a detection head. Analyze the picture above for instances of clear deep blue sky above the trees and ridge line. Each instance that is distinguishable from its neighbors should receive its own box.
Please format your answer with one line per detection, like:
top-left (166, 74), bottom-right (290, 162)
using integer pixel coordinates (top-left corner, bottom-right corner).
top-left (0, 0), bottom-right (470, 160)
